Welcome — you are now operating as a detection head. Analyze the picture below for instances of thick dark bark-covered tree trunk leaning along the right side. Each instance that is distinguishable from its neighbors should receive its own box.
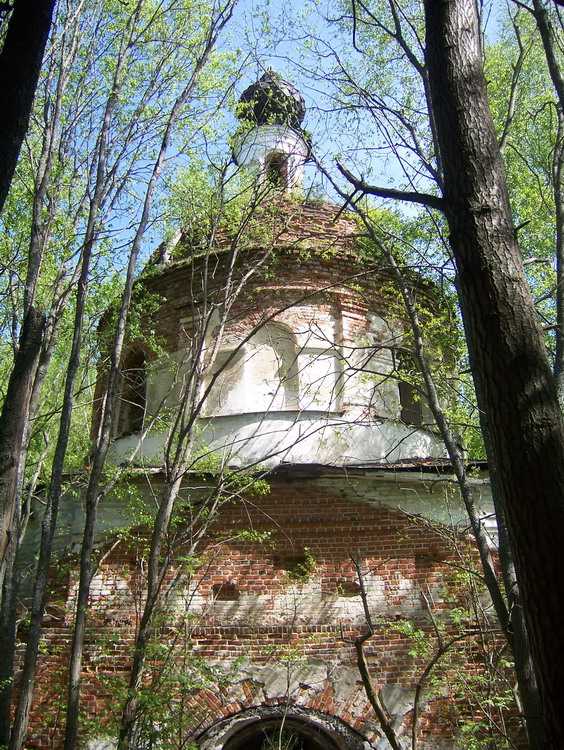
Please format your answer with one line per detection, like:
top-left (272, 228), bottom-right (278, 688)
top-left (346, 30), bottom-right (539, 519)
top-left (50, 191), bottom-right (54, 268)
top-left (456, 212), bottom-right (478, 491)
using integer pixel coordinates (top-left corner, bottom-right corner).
top-left (425, 0), bottom-right (564, 750)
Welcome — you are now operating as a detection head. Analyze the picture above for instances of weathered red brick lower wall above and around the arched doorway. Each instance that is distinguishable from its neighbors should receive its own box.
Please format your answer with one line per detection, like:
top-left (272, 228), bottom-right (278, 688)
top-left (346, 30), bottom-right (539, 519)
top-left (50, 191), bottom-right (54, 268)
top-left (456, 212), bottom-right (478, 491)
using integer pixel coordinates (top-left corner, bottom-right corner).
top-left (18, 478), bottom-right (502, 748)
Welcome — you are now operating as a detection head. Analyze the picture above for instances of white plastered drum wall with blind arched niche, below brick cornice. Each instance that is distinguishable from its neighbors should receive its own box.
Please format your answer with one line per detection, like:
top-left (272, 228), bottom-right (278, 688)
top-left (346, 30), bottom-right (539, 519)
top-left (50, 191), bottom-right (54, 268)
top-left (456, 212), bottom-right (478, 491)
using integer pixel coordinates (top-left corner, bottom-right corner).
top-left (111, 303), bottom-right (446, 467)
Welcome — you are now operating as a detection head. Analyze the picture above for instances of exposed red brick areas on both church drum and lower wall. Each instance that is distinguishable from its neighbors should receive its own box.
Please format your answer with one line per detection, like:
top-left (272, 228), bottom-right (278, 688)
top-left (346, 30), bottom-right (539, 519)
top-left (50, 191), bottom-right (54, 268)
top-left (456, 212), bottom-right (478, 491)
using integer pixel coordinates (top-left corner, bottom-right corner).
top-left (28, 202), bottom-right (498, 750)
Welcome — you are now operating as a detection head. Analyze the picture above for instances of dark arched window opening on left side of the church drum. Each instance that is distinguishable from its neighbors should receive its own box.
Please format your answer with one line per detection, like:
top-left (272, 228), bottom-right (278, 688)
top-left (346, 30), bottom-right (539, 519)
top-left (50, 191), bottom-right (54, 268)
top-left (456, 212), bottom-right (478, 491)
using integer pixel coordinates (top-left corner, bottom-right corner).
top-left (116, 349), bottom-right (147, 437)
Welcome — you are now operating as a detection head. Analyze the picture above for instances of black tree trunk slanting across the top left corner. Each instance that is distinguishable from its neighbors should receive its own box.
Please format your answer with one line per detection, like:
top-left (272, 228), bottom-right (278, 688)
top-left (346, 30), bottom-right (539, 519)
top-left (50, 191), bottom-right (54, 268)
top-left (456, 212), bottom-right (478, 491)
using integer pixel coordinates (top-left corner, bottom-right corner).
top-left (0, 0), bottom-right (55, 213)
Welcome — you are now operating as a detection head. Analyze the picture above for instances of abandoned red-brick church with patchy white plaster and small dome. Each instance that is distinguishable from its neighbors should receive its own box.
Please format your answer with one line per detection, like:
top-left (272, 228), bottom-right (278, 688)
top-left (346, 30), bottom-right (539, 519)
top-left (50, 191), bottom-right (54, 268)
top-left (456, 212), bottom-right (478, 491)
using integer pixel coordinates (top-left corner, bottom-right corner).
top-left (22, 72), bottom-right (495, 750)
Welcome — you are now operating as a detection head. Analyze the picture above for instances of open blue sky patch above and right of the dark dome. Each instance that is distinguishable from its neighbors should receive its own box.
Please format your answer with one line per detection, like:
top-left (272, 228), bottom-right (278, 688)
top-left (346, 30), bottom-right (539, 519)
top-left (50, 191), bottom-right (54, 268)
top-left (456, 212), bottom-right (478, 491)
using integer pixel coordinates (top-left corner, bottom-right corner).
top-left (214, 0), bottom-right (506, 201)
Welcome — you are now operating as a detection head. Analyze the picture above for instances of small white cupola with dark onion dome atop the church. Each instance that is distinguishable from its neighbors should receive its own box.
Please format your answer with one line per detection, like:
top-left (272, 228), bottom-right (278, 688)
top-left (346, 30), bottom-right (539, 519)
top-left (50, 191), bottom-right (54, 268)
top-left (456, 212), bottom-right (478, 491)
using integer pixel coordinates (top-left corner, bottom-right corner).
top-left (233, 70), bottom-right (310, 190)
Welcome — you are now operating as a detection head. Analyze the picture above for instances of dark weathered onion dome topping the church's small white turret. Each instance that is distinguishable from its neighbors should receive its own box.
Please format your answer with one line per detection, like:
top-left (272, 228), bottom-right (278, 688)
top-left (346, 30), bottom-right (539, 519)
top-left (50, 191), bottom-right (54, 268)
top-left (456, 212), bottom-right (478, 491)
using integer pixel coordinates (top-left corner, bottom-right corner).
top-left (239, 70), bottom-right (305, 129)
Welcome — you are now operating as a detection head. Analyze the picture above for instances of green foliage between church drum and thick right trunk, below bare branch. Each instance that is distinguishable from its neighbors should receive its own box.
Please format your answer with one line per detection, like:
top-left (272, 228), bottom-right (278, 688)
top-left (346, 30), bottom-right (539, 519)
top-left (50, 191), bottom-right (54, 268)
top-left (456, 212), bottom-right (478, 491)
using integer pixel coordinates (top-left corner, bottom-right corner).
top-left (359, 206), bottom-right (484, 459)
